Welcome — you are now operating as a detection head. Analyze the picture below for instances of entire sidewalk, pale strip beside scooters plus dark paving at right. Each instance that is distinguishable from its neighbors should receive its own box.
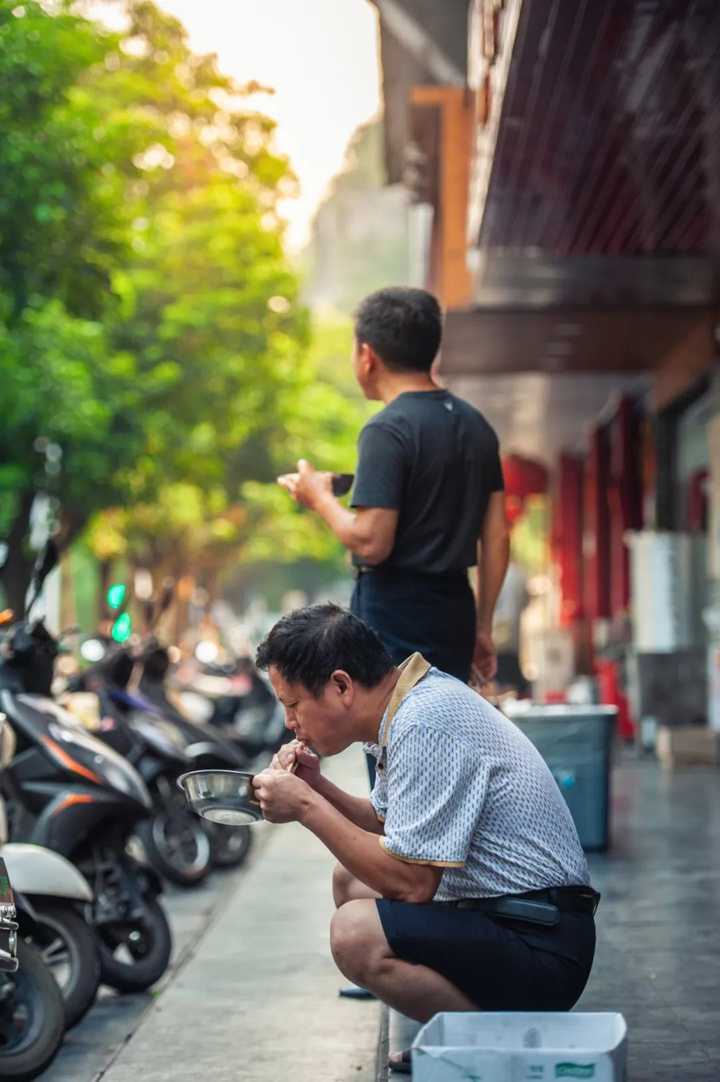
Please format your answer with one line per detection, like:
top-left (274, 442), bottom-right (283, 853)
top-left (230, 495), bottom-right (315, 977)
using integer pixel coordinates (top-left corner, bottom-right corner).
top-left (92, 751), bottom-right (720, 1082)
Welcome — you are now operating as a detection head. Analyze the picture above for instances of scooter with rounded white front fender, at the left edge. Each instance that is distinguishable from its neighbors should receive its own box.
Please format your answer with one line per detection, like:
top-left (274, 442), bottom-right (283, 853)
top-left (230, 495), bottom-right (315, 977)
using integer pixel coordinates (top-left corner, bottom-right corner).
top-left (0, 715), bottom-right (100, 1025)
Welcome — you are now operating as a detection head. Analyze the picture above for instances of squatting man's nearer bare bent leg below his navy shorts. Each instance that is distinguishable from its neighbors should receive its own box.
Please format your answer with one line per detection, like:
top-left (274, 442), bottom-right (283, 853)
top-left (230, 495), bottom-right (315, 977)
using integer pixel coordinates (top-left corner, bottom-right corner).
top-left (330, 899), bottom-right (477, 1021)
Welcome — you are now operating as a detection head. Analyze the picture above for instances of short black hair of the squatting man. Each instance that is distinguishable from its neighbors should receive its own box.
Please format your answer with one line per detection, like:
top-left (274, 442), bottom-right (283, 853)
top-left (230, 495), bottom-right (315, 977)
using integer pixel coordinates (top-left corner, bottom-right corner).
top-left (256, 604), bottom-right (393, 698)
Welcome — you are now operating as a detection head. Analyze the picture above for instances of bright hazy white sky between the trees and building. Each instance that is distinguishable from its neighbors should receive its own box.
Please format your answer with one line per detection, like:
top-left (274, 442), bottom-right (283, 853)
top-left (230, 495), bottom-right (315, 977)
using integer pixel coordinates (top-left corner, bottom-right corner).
top-left (157, 0), bottom-right (380, 248)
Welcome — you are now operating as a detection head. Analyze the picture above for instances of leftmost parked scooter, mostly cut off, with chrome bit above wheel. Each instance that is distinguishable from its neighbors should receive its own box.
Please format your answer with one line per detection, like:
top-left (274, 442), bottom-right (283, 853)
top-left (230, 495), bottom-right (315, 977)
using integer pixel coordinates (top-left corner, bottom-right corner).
top-left (0, 857), bottom-right (65, 1082)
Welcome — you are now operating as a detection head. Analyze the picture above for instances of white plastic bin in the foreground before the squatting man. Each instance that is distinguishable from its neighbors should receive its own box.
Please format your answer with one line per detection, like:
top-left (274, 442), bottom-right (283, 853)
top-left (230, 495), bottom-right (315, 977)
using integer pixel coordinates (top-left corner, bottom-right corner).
top-left (413, 1012), bottom-right (627, 1082)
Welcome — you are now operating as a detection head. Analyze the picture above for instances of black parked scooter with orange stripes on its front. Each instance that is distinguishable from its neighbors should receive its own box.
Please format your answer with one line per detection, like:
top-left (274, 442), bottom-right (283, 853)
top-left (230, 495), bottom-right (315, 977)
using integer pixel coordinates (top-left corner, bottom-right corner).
top-left (0, 543), bottom-right (172, 991)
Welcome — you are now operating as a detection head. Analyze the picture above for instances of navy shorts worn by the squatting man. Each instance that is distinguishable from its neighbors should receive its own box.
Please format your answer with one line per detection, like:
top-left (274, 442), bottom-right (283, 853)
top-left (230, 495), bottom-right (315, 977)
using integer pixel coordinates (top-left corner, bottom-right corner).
top-left (377, 898), bottom-right (595, 1011)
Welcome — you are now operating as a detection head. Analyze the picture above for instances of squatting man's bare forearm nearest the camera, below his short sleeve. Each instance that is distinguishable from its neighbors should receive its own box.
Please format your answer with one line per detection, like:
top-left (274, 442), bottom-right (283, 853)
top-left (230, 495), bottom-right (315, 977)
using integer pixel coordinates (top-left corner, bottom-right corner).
top-left (300, 789), bottom-right (437, 902)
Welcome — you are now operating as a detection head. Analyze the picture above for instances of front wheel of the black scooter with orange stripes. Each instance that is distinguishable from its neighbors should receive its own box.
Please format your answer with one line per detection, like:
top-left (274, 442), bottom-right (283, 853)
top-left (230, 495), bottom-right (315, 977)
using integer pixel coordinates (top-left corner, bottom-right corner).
top-left (97, 898), bottom-right (172, 992)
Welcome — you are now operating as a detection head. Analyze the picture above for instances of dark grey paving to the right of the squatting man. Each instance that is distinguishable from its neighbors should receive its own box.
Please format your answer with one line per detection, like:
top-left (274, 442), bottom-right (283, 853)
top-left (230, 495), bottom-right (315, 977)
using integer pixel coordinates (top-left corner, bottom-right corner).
top-left (383, 754), bottom-right (720, 1082)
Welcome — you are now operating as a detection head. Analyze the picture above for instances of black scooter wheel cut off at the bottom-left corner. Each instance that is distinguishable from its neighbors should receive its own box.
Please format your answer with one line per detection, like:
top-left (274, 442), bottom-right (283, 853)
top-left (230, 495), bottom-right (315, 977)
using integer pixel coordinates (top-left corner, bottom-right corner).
top-left (0, 939), bottom-right (65, 1082)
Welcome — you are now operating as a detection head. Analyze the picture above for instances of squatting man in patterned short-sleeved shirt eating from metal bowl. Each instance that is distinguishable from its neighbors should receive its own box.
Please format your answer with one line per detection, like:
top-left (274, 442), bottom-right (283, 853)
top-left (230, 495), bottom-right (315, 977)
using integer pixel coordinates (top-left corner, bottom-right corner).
top-left (253, 605), bottom-right (598, 1069)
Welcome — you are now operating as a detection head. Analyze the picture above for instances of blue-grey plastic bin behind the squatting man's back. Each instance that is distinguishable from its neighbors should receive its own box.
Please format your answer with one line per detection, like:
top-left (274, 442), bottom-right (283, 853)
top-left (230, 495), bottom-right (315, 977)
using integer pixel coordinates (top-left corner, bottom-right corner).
top-left (507, 703), bottom-right (617, 852)
